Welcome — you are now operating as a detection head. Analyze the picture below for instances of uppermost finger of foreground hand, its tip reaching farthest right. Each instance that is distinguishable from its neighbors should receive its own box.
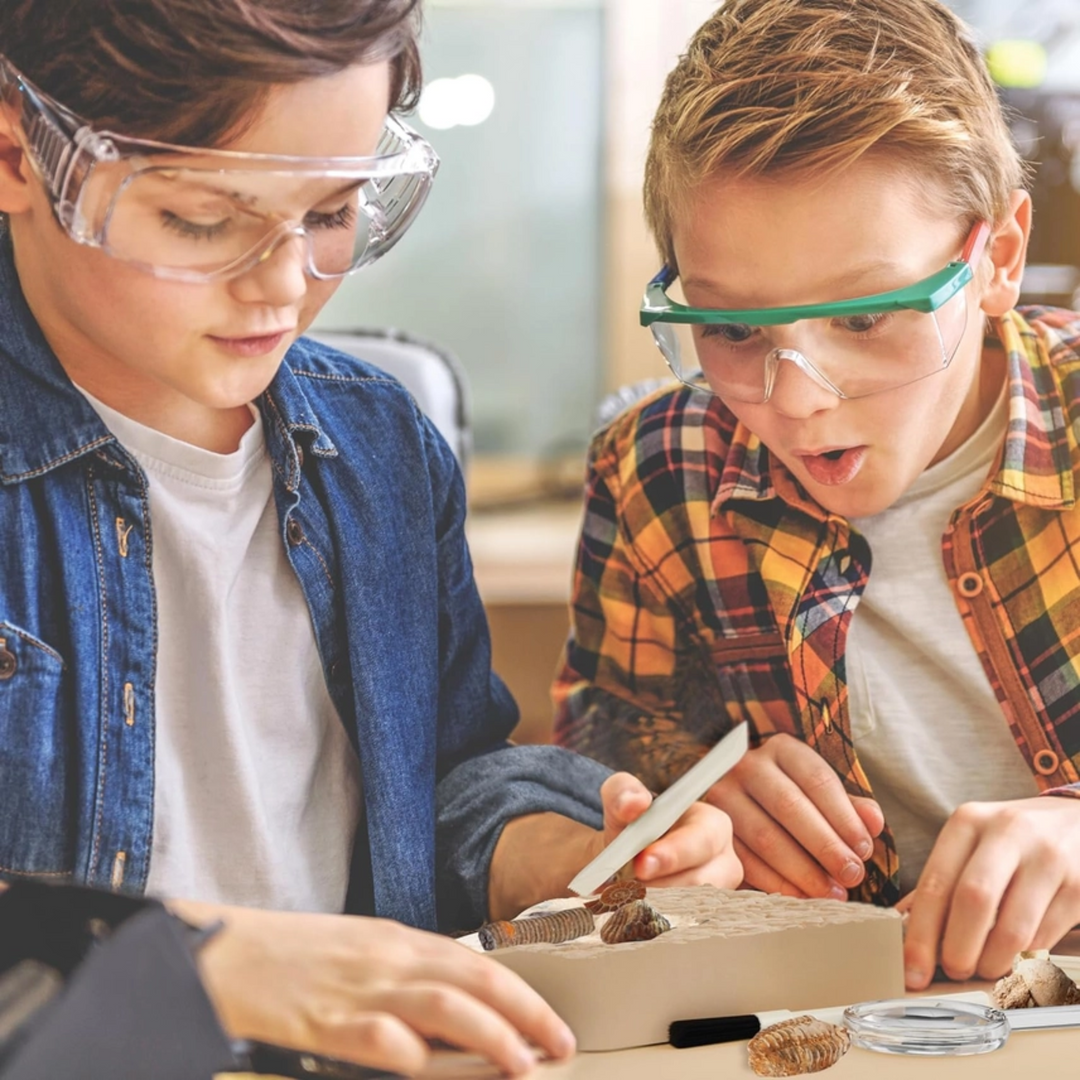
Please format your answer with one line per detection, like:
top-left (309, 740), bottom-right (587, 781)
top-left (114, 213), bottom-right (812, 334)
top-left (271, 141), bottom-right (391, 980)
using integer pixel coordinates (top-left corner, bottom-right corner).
top-left (421, 942), bottom-right (575, 1058)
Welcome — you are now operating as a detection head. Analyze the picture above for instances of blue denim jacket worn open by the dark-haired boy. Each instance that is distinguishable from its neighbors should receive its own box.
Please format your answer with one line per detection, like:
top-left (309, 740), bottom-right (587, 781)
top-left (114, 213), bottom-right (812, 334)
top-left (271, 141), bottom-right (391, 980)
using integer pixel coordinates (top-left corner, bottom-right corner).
top-left (0, 238), bottom-right (607, 929)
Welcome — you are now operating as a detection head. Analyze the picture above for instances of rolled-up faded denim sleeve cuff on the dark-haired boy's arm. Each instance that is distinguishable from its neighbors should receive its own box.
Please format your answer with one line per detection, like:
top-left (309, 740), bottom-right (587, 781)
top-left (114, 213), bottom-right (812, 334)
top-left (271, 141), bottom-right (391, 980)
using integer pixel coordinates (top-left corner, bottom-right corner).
top-left (435, 745), bottom-right (611, 933)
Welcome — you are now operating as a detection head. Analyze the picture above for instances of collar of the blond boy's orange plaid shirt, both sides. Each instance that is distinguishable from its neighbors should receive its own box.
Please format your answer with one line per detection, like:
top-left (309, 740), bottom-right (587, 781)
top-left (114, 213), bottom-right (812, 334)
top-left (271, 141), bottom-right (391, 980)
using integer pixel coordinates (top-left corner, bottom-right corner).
top-left (712, 311), bottom-right (1076, 519)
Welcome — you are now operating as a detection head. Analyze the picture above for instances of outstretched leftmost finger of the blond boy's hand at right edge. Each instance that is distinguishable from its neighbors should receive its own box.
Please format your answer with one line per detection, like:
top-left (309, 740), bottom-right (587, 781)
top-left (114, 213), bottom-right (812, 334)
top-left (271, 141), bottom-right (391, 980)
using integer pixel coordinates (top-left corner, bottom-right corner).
top-left (904, 815), bottom-right (975, 990)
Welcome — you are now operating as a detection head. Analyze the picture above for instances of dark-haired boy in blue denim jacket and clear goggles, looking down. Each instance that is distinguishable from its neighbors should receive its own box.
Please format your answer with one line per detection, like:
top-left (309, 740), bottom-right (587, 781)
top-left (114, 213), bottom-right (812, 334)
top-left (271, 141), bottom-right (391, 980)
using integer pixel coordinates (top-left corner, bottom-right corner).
top-left (0, 0), bottom-right (741, 1072)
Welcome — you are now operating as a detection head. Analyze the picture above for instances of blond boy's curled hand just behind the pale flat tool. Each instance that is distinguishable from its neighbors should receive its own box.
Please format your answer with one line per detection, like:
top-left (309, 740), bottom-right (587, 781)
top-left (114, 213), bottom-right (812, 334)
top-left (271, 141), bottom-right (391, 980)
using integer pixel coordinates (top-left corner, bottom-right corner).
top-left (705, 734), bottom-right (885, 900)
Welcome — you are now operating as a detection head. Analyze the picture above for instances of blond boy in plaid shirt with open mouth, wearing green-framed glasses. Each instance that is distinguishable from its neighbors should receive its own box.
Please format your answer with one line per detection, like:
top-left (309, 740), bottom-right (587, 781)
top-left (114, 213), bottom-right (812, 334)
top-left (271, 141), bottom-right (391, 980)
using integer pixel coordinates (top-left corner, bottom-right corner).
top-left (555, 0), bottom-right (1080, 989)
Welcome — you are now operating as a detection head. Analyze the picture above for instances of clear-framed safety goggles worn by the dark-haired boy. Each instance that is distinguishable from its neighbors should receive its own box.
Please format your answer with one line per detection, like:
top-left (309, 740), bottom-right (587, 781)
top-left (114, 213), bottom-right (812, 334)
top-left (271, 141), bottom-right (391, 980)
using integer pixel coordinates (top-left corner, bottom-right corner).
top-left (0, 55), bottom-right (438, 282)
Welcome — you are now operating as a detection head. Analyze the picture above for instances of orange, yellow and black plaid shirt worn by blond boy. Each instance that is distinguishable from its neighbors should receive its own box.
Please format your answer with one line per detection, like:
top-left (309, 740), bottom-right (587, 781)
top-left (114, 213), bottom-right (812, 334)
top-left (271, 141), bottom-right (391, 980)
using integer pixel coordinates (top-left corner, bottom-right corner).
top-left (553, 308), bottom-right (1080, 904)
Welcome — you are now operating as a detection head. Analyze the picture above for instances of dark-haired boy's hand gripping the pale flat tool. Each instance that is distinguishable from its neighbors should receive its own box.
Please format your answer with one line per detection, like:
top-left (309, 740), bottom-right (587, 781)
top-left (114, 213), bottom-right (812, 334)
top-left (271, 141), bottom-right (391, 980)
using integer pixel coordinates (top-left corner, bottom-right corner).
top-left (597, 772), bottom-right (743, 889)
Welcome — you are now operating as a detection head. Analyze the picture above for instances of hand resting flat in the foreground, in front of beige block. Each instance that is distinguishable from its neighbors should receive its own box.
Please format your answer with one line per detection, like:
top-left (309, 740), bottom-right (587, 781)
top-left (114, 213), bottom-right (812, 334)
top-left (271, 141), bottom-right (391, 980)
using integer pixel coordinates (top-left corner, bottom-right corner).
top-left (170, 902), bottom-right (573, 1076)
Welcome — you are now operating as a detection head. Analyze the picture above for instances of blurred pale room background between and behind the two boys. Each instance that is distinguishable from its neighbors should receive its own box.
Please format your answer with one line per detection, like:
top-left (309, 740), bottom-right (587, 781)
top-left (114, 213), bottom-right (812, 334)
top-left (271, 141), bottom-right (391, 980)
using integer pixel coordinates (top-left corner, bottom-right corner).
top-left (316, 0), bottom-right (1080, 741)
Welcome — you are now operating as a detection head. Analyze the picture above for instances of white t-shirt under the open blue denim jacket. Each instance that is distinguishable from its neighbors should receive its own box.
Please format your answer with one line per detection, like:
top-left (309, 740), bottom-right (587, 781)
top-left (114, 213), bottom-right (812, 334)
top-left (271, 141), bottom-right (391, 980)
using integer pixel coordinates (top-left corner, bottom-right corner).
top-left (83, 391), bottom-right (360, 912)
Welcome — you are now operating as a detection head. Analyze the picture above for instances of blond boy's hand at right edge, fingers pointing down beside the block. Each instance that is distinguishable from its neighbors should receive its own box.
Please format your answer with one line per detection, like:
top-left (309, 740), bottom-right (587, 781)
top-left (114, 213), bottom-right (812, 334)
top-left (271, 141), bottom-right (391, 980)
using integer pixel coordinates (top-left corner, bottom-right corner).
top-left (897, 795), bottom-right (1080, 990)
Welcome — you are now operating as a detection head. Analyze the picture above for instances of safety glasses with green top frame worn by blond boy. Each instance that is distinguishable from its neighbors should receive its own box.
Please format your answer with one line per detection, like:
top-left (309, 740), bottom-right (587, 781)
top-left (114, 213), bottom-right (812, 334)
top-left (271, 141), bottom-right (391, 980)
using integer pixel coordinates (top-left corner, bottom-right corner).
top-left (640, 222), bottom-right (990, 404)
